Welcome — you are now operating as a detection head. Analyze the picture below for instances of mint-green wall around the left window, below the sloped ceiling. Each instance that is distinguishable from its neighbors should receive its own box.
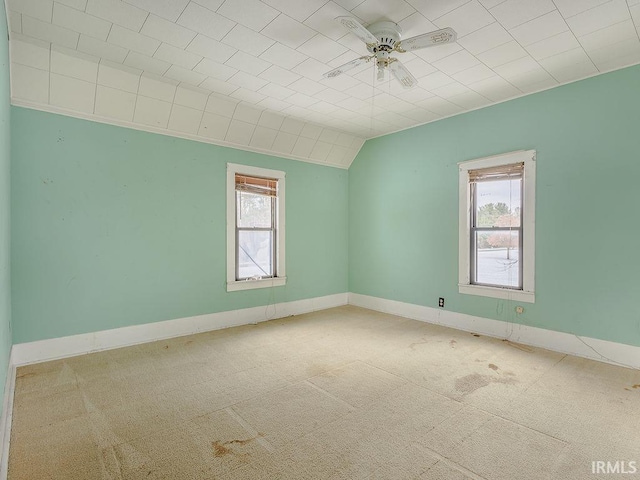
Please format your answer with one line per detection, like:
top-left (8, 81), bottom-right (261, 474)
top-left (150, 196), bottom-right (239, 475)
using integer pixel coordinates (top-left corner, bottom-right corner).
top-left (11, 107), bottom-right (348, 343)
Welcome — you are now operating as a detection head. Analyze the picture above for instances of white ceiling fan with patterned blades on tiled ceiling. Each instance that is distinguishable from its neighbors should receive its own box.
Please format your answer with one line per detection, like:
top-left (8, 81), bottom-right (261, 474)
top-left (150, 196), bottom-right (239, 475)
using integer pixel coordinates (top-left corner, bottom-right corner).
top-left (323, 17), bottom-right (457, 88)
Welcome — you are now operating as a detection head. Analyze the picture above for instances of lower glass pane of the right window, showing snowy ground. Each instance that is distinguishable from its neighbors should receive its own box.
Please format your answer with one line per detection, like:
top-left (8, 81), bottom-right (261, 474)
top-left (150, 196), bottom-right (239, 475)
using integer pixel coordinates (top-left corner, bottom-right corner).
top-left (474, 230), bottom-right (520, 288)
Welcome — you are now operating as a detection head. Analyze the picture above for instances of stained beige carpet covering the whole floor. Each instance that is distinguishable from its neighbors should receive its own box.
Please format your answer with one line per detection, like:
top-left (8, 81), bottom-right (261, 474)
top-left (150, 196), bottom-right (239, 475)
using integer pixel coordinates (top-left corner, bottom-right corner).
top-left (9, 307), bottom-right (640, 480)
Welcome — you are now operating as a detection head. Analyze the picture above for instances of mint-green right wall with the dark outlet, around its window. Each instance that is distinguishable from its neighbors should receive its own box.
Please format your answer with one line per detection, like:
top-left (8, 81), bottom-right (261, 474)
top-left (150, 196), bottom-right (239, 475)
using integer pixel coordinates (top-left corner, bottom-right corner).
top-left (349, 66), bottom-right (640, 345)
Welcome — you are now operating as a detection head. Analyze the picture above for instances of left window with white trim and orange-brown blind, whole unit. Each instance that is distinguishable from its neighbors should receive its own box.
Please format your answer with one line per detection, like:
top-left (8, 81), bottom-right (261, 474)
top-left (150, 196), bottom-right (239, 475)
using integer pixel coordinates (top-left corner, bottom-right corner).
top-left (227, 163), bottom-right (286, 291)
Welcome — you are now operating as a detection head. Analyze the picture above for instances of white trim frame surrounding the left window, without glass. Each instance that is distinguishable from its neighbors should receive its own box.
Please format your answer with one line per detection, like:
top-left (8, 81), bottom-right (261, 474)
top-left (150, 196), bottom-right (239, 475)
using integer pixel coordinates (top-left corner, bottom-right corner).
top-left (227, 163), bottom-right (287, 292)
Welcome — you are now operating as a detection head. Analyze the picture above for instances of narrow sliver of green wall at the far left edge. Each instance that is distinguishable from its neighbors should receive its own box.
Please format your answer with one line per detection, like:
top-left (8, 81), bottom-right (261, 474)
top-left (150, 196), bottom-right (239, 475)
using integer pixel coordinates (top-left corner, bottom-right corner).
top-left (0, 2), bottom-right (11, 413)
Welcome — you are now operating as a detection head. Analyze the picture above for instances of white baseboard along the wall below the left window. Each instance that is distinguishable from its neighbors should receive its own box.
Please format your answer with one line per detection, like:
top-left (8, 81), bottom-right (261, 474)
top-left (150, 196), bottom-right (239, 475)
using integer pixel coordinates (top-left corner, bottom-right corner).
top-left (11, 293), bottom-right (348, 368)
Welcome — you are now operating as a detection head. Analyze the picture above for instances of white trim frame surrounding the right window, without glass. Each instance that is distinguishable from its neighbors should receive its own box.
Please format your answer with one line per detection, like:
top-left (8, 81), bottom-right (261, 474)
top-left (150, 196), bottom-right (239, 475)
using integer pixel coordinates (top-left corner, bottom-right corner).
top-left (458, 150), bottom-right (536, 303)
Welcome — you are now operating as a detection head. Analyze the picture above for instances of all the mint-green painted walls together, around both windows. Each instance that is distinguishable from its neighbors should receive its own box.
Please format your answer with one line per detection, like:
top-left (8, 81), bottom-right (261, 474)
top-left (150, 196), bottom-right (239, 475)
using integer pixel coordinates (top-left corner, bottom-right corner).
top-left (8, 60), bottom-right (640, 348)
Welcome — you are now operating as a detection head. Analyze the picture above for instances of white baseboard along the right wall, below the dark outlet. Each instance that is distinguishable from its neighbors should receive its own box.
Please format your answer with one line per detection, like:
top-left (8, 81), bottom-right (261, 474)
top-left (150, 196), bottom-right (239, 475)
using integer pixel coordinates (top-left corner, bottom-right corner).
top-left (349, 293), bottom-right (640, 368)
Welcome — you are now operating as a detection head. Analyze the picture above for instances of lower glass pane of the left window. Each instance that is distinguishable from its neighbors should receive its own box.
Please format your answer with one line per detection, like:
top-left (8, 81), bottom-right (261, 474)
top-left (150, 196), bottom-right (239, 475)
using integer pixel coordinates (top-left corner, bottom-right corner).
top-left (238, 230), bottom-right (273, 279)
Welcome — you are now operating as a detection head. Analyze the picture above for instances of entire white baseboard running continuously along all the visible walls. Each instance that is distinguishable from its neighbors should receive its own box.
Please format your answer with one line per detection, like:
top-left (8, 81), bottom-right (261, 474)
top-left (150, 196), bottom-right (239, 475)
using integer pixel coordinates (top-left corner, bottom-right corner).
top-left (0, 293), bottom-right (640, 480)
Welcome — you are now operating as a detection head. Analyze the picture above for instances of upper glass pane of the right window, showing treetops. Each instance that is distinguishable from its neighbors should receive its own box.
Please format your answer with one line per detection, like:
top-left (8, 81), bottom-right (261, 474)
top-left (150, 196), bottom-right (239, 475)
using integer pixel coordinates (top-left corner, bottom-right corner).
top-left (475, 179), bottom-right (522, 227)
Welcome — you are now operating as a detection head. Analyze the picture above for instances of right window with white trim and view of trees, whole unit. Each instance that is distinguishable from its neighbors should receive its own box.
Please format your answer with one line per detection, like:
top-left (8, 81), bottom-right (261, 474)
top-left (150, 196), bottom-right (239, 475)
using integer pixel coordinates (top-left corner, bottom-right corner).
top-left (459, 150), bottom-right (536, 303)
